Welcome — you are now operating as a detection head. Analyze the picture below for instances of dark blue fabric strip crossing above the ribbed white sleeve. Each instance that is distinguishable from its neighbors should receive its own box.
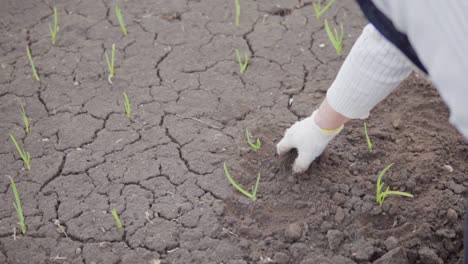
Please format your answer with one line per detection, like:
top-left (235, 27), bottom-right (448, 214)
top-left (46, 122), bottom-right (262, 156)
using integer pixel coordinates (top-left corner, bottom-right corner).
top-left (357, 0), bottom-right (427, 74)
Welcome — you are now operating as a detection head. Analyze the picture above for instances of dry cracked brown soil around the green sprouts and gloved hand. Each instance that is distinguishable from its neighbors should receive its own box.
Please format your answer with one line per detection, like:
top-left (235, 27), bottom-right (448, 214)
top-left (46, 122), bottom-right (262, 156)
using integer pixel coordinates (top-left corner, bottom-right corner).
top-left (0, 0), bottom-right (468, 264)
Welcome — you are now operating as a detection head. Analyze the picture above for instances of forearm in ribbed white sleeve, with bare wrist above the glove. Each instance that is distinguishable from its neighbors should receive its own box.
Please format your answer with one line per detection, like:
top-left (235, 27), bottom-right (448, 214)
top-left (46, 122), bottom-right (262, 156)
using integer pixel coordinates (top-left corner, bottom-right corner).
top-left (322, 25), bottom-right (412, 121)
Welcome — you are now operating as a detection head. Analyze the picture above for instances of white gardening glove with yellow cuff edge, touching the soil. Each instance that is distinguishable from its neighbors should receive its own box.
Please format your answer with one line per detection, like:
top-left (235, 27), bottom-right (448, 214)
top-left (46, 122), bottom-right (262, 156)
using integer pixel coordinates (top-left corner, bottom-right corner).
top-left (276, 110), bottom-right (343, 173)
